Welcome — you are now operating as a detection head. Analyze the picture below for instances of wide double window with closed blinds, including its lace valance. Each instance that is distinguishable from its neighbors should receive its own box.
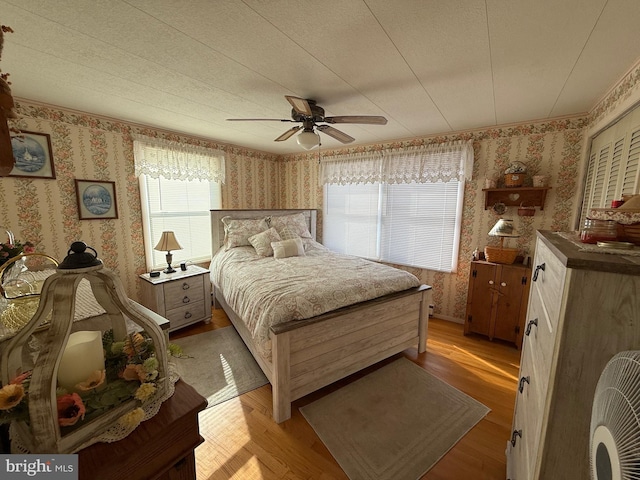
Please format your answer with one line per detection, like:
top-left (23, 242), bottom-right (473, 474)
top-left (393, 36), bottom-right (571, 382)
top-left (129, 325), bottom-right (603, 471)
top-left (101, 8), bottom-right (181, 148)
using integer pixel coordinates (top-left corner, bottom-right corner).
top-left (322, 144), bottom-right (473, 272)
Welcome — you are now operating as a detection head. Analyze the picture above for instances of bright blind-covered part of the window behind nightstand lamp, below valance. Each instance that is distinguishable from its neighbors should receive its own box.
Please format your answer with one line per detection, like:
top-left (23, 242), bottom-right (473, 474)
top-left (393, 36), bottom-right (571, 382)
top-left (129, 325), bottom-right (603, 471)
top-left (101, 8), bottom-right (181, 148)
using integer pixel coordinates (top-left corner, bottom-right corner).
top-left (140, 174), bottom-right (222, 269)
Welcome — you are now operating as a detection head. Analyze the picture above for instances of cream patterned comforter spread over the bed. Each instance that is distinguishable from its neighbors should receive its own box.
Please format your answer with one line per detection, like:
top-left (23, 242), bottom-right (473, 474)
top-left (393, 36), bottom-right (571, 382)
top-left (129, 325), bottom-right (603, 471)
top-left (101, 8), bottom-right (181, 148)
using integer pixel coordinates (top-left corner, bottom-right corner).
top-left (210, 239), bottom-right (420, 359)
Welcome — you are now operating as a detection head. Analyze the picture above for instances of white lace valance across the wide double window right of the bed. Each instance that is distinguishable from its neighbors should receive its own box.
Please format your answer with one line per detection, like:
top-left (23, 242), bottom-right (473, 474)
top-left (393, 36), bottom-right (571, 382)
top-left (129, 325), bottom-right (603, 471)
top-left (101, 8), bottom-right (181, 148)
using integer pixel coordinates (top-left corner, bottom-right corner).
top-left (320, 140), bottom-right (473, 185)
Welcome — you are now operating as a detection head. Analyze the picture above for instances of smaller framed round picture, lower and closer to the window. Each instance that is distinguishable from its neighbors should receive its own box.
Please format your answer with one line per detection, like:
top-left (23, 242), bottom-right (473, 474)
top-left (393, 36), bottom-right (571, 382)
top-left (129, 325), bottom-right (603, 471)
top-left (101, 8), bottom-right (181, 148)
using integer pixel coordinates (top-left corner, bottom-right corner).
top-left (76, 179), bottom-right (118, 220)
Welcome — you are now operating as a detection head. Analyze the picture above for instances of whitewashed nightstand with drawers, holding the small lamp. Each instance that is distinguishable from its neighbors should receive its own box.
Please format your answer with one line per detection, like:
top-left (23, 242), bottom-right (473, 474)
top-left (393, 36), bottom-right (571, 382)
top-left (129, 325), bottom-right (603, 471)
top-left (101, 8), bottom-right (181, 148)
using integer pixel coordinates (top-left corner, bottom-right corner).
top-left (140, 265), bottom-right (211, 332)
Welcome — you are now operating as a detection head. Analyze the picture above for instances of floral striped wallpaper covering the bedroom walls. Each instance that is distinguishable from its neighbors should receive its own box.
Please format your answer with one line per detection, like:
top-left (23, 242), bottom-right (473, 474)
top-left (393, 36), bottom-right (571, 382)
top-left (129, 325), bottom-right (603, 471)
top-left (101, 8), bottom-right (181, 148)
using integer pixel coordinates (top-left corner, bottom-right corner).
top-left (0, 56), bottom-right (640, 322)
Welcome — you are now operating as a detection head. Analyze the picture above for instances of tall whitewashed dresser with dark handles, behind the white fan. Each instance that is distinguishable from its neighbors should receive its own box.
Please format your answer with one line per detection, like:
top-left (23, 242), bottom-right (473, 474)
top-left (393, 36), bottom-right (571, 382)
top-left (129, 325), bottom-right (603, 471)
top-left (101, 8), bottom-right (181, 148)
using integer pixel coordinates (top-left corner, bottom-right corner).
top-left (507, 232), bottom-right (640, 480)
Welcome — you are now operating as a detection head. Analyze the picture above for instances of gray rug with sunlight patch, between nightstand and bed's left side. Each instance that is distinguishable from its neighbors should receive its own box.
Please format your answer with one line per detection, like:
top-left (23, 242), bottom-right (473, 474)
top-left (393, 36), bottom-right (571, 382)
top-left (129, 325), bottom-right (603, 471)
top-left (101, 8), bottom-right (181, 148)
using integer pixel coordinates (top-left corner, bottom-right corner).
top-left (170, 327), bottom-right (268, 408)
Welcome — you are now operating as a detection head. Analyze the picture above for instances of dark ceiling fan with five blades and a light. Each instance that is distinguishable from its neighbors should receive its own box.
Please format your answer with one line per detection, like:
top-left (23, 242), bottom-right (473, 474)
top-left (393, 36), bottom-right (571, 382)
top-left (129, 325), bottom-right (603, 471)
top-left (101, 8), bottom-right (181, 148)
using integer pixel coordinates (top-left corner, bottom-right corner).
top-left (227, 95), bottom-right (387, 150)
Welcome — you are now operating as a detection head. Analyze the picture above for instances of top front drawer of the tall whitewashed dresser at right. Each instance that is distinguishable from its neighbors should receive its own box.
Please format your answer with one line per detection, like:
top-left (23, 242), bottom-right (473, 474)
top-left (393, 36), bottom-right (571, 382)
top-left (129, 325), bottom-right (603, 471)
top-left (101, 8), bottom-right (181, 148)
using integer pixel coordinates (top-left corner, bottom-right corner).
top-left (531, 240), bottom-right (567, 327)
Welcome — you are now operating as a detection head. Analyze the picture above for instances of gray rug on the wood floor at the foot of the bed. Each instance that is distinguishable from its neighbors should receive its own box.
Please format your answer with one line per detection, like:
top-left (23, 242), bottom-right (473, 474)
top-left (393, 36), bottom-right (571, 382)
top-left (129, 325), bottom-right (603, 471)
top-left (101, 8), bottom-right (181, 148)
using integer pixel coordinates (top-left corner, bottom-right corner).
top-left (300, 358), bottom-right (490, 480)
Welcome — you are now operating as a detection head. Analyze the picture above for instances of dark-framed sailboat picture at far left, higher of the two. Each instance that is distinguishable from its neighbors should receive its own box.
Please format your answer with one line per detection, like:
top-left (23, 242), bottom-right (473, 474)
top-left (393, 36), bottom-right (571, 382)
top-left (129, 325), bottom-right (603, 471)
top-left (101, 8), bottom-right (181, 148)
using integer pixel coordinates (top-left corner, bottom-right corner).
top-left (9, 131), bottom-right (56, 178)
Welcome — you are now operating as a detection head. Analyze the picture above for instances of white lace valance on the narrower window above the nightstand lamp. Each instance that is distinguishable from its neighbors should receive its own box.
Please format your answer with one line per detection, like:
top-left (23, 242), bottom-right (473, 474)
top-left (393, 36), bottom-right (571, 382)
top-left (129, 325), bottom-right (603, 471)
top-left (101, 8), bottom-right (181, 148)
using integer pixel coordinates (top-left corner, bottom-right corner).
top-left (133, 135), bottom-right (224, 183)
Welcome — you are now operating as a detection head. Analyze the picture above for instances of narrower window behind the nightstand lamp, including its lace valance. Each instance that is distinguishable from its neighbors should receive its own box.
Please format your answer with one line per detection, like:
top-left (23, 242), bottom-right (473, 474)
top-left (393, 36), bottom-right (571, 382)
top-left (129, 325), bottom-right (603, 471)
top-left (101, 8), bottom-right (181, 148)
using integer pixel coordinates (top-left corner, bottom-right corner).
top-left (134, 135), bottom-right (224, 269)
